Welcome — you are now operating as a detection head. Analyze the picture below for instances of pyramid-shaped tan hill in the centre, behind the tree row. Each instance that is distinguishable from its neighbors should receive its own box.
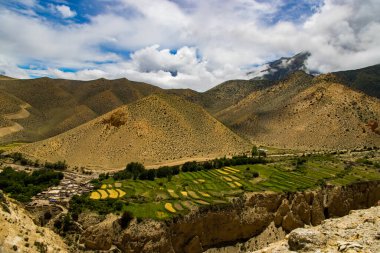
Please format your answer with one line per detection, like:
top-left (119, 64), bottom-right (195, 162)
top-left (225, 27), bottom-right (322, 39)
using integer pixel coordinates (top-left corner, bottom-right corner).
top-left (20, 95), bottom-right (250, 168)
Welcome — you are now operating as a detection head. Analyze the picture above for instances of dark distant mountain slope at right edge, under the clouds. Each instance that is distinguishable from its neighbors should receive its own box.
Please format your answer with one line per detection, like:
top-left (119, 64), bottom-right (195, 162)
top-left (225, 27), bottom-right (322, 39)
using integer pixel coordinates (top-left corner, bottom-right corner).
top-left (334, 64), bottom-right (380, 98)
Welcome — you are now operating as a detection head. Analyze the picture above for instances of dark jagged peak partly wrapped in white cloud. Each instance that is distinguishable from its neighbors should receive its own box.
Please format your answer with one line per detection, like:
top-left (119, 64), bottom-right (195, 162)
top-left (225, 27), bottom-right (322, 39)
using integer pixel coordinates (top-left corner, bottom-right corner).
top-left (247, 52), bottom-right (311, 81)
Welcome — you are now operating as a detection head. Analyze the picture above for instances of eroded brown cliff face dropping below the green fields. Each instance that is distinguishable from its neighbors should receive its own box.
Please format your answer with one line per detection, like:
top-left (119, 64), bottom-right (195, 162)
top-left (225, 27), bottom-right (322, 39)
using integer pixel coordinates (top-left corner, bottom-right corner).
top-left (78, 181), bottom-right (380, 253)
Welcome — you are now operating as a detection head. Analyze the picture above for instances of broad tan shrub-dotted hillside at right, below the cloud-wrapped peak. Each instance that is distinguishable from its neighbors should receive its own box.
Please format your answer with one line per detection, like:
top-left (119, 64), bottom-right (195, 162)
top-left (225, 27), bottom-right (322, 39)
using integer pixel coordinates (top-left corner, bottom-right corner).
top-left (216, 72), bottom-right (380, 149)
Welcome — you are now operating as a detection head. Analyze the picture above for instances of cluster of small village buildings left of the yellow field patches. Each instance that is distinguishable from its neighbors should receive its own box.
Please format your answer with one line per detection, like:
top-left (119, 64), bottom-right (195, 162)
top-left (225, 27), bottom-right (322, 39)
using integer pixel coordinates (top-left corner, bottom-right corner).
top-left (29, 173), bottom-right (93, 206)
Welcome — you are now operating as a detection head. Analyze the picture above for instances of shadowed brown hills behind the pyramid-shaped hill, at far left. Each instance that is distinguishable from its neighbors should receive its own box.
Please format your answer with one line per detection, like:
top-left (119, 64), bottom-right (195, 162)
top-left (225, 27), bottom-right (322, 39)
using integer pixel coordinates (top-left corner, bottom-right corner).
top-left (0, 78), bottom-right (161, 143)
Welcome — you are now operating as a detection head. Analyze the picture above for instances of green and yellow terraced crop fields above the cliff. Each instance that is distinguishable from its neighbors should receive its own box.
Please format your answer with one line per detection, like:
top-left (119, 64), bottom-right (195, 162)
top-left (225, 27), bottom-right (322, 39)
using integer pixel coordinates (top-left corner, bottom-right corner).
top-left (90, 154), bottom-right (380, 219)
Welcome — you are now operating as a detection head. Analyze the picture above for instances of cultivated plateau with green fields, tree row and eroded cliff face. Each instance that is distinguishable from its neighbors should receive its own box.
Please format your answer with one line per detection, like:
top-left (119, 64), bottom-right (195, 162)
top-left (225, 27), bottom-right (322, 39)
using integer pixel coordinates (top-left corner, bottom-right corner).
top-left (0, 149), bottom-right (380, 252)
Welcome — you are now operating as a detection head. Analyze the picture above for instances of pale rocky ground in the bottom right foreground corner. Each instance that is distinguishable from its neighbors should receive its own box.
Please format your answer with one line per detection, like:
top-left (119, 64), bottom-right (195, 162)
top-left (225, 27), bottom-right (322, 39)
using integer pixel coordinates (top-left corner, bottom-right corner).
top-left (254, 206), bottom-right (380, 253)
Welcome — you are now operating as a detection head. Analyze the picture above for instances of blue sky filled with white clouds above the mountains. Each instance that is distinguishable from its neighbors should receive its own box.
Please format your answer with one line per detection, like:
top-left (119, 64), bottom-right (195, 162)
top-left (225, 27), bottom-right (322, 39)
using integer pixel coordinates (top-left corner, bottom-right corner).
top-left (0, 0), bottom-right (380, 91)
